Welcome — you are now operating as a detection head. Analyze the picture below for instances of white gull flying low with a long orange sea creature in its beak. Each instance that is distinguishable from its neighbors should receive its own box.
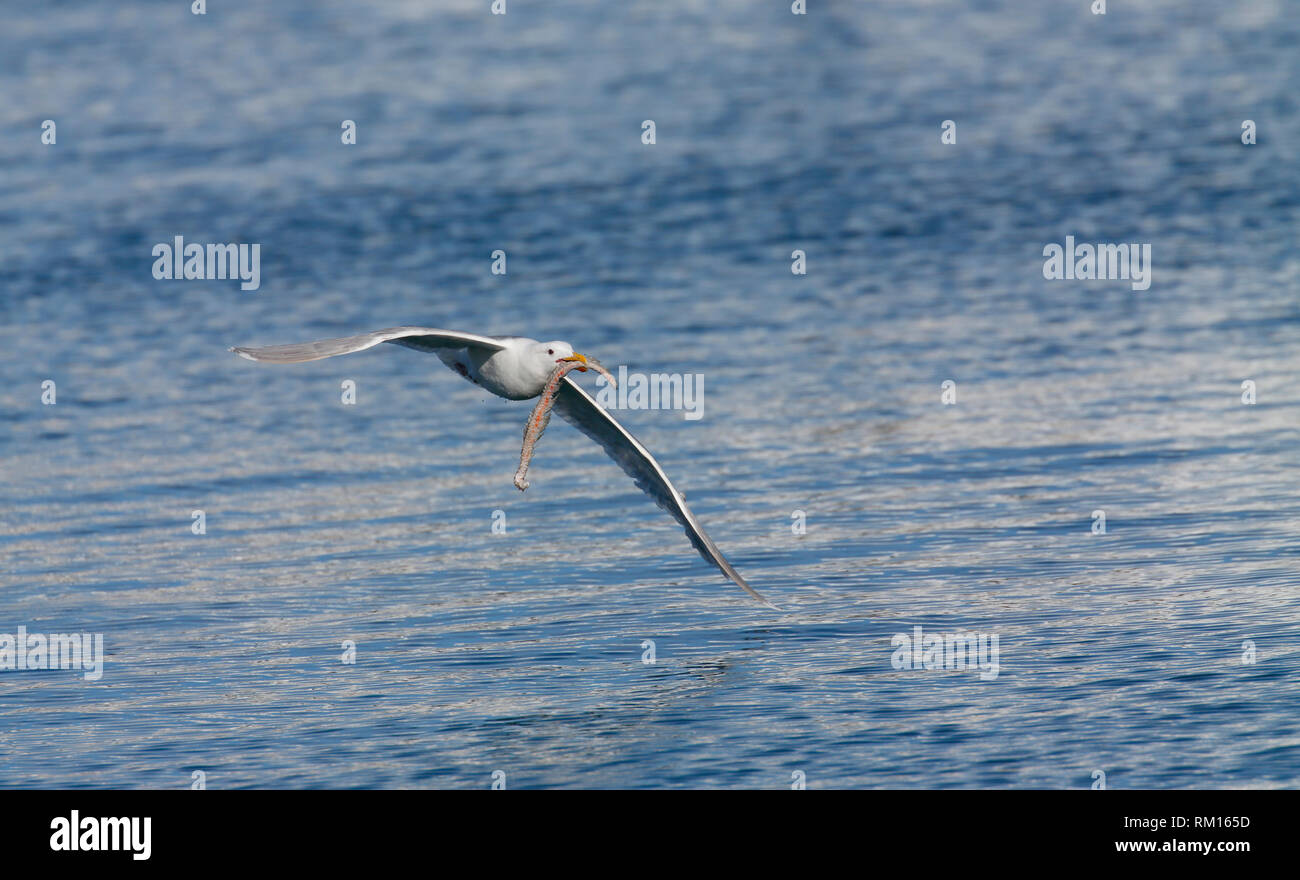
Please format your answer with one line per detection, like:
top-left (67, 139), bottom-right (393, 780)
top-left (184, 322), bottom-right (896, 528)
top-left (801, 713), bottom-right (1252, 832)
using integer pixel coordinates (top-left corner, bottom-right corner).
top-left (230, 328), bottom-right (780, 611)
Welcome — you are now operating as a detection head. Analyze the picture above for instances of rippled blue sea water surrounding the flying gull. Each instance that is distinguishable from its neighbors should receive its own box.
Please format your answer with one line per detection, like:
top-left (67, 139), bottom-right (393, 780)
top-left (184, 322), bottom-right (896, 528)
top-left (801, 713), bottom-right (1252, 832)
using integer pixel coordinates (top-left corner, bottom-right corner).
top-left (0, 0), bottom-right (1300, 788)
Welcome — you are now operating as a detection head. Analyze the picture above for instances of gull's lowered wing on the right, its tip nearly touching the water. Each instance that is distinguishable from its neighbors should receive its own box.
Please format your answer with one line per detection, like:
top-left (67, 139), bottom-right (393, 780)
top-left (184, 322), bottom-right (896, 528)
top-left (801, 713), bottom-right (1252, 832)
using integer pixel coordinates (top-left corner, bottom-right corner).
top-left (555, 376), bottom-right (780, 611)
